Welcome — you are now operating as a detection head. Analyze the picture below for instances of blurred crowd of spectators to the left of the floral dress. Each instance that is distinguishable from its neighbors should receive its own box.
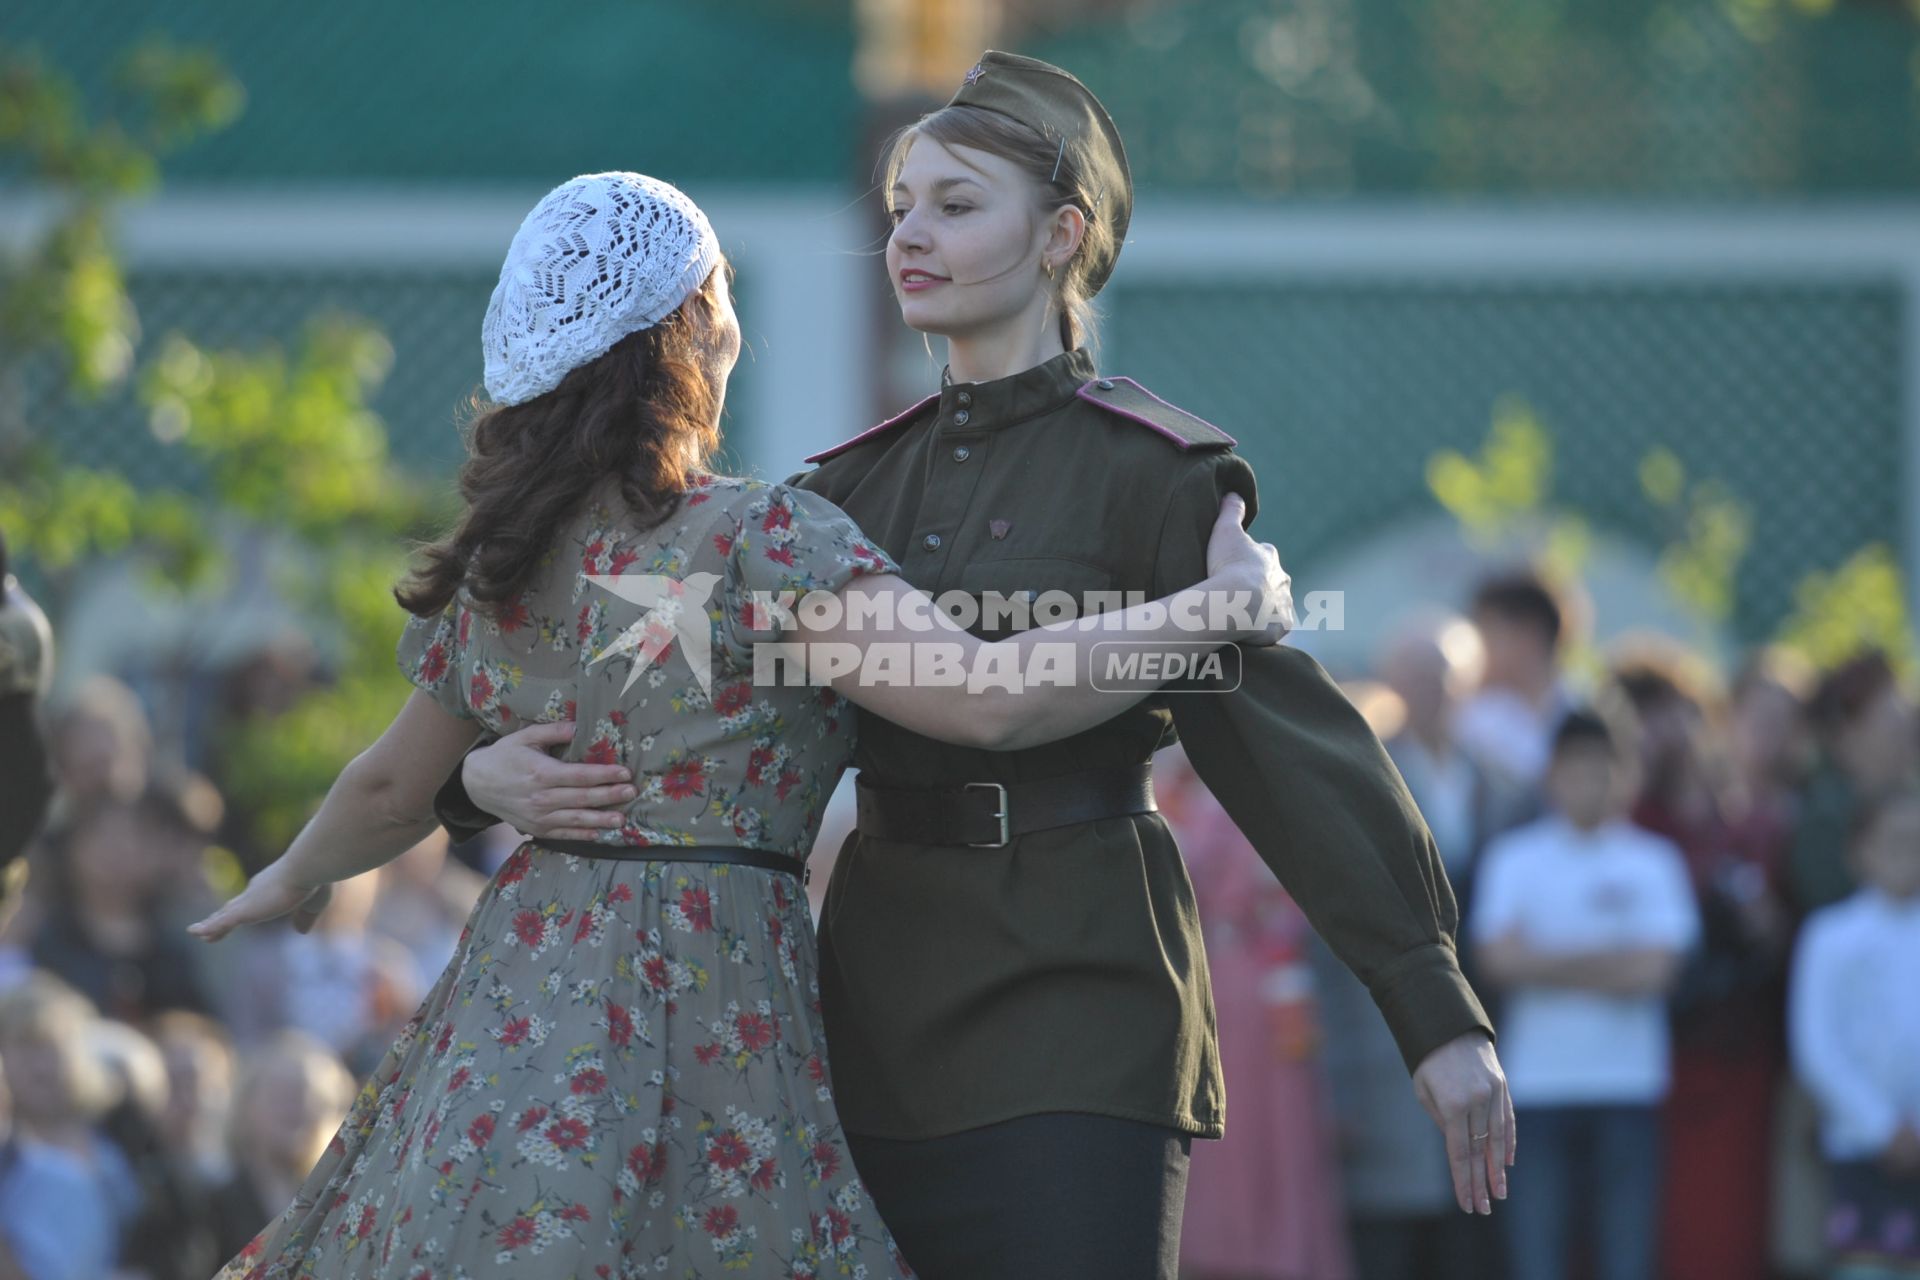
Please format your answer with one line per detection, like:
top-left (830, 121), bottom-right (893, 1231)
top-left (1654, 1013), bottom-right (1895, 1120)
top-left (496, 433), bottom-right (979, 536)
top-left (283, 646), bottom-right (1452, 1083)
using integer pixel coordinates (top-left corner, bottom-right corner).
top-left (0, 625), bottom-right (486, 1280)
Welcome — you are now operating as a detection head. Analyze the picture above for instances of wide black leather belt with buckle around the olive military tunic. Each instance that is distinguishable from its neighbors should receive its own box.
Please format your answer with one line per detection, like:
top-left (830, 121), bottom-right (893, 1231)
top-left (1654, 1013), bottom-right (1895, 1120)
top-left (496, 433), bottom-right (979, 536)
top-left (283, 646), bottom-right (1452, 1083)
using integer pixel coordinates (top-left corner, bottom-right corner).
top-left (854, 762), bottom-right (1160, 848)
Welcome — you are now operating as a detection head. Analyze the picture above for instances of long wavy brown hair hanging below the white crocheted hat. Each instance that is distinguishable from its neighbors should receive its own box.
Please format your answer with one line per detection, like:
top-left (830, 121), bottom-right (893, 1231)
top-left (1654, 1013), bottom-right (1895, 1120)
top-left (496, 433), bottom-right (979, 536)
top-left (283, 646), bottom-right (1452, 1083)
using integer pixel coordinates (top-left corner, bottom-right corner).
top-left (394, 265), bottom-right (732, 618)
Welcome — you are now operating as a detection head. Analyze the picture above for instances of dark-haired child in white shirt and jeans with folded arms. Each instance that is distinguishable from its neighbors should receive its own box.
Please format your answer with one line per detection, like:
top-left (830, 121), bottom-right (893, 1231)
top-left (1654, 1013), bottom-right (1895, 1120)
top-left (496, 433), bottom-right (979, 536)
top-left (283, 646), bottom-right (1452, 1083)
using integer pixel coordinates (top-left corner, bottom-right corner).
top-left (1467, 710), bottom-right (1699, 1280)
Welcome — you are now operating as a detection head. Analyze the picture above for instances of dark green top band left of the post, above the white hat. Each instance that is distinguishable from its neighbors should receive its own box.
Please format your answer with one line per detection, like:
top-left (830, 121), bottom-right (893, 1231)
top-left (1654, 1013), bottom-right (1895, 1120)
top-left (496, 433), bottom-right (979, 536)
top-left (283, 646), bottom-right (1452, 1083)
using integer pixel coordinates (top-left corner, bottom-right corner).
top-left (0, 0), bottom-right (860, 186)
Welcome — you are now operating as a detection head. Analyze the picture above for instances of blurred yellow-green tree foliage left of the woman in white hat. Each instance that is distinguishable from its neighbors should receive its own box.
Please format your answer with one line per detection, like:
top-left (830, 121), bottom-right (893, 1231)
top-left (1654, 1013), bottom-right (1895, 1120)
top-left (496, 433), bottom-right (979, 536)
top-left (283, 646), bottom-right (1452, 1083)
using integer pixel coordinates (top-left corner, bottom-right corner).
top-left (0, 42), bottom-right (447, 850)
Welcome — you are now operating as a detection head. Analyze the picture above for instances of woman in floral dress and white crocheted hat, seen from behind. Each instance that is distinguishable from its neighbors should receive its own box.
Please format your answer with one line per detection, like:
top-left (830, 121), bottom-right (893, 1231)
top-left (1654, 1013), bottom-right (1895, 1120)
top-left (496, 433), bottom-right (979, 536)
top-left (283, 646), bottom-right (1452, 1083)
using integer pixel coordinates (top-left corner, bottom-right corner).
top-left (192, 175), bottom-right (1284, 1280)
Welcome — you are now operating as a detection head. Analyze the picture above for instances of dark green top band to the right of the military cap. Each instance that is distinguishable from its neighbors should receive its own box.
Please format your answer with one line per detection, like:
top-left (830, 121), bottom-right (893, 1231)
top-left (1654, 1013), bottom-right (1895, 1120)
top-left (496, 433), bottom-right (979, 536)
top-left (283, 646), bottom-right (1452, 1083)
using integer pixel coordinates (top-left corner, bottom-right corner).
top-left (1044, 0), bottom-right (1920, 196)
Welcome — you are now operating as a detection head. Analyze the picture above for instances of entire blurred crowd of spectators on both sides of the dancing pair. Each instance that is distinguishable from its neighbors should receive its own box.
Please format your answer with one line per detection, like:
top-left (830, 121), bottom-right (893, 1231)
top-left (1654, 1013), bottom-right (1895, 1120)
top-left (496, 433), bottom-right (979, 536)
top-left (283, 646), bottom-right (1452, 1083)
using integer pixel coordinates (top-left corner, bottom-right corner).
top-left (0, 570), bottom-right (1920, 1280)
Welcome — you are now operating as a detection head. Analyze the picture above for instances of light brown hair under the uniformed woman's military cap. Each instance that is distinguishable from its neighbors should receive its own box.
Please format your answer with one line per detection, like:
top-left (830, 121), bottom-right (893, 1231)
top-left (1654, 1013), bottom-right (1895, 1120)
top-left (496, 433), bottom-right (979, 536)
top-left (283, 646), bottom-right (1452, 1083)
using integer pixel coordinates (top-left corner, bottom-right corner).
top-left (879, 104), bottom-right (1114, 351)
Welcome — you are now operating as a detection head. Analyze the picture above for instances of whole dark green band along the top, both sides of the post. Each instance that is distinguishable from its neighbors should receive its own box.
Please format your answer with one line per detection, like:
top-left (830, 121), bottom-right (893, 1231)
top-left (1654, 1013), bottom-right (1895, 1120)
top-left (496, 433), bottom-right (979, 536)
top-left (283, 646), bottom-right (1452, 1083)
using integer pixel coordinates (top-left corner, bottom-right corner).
top-left (0, 0), bottom-right (1920, 196)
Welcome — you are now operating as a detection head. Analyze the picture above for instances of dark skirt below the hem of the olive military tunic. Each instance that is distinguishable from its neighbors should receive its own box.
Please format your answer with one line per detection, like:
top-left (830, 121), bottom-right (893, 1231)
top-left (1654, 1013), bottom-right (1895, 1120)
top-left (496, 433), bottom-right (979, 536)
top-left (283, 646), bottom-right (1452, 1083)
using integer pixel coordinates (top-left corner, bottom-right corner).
top-left (847, 1113), bottom-right (1192, 1280)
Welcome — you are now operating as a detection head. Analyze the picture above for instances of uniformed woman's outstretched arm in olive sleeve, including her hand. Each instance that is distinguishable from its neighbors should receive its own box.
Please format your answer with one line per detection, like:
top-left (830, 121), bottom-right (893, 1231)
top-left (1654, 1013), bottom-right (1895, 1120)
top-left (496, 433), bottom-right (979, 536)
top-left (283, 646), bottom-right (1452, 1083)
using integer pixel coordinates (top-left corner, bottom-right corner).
top-left (1156, 453), bottom-right (1513, 1213)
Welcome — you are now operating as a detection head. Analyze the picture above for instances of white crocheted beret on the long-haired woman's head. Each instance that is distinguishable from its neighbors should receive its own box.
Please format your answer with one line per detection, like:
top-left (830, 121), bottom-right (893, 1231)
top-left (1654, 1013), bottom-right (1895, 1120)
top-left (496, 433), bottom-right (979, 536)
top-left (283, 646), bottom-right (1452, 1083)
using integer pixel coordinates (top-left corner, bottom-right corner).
top-left (480, 173), bottom-right (720, 405)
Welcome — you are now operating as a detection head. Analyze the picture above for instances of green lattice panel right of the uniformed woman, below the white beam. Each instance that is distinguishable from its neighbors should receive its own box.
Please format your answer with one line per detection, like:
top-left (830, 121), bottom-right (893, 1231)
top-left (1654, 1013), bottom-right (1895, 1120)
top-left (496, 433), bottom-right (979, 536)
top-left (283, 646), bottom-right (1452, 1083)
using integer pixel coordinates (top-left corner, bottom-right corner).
top-left (1102, 278), bottom-right (1903, 639)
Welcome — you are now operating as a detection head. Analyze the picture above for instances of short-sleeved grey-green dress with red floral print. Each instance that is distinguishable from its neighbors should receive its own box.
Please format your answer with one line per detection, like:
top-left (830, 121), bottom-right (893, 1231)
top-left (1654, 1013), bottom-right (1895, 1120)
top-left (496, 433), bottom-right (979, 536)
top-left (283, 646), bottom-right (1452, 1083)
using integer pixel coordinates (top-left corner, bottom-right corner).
top-left (219, 476), bottom-right (910, 1280)
